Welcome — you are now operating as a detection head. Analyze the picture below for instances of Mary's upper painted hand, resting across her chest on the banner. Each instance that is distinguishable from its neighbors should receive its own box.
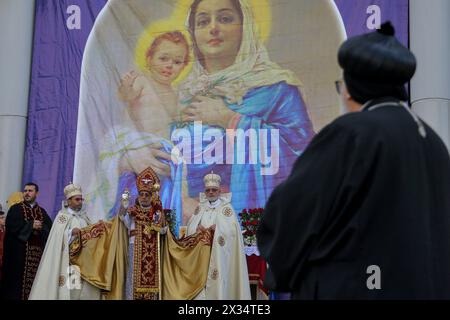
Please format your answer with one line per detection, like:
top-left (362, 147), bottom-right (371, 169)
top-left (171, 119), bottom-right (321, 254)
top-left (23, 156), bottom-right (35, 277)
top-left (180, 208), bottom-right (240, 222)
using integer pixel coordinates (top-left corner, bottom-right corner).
top-left (181, 96), bottom-right (236, 129)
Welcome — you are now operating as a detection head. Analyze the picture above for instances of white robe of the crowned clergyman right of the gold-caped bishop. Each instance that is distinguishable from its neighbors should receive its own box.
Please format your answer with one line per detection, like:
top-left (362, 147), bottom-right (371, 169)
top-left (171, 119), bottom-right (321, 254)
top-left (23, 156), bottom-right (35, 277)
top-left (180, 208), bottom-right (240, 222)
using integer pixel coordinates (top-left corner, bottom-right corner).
top-left (187, 193), bottom-right (251, 300)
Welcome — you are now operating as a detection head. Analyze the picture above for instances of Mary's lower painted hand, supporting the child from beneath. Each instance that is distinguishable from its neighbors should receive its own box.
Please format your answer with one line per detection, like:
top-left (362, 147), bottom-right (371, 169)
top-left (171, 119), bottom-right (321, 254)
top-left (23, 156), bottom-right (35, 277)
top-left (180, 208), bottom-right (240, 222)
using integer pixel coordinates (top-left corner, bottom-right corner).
top-left (120, 143), bottom-right (171, 177)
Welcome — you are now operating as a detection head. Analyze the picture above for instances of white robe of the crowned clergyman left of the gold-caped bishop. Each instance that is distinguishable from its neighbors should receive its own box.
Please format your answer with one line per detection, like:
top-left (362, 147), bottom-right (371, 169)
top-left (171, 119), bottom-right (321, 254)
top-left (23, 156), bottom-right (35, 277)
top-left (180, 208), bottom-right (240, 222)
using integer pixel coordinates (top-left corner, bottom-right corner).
top-left (30, 206), bottom-right (100, 300)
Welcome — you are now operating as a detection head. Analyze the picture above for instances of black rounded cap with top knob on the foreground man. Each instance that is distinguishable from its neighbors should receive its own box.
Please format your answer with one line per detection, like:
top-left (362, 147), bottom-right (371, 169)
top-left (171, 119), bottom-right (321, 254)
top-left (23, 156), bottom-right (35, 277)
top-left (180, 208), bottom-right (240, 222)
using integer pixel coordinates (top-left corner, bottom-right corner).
top-left (338, 22), bottom-right (416, 104)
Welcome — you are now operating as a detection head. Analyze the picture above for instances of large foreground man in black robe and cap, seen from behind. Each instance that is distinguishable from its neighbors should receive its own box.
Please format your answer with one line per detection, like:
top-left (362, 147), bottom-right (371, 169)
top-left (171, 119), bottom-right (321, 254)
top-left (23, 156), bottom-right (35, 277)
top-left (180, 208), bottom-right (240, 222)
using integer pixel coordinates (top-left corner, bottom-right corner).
top-left (257, 23), bottom-right (450, 299)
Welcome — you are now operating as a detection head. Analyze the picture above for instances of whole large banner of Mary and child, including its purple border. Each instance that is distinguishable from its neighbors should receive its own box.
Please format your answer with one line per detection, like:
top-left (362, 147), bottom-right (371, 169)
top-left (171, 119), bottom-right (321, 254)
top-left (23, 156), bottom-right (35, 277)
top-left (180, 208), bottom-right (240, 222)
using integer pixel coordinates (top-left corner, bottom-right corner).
top-left (24, 0), bottom-right (408, 230)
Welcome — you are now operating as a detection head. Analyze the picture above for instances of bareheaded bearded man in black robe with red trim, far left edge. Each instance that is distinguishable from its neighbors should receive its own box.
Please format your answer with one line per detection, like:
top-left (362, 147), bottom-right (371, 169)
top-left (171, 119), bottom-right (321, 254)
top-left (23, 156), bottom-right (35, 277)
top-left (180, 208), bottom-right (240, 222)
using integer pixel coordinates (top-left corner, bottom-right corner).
top-left (1, 183), bottom-right (52, 300)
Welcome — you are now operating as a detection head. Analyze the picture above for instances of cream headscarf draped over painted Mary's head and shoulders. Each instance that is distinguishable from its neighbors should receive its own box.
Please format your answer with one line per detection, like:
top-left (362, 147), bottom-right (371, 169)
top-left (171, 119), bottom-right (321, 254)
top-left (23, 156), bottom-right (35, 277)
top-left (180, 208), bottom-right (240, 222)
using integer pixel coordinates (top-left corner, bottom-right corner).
top-left (180, 0), bottom-right (301, 104)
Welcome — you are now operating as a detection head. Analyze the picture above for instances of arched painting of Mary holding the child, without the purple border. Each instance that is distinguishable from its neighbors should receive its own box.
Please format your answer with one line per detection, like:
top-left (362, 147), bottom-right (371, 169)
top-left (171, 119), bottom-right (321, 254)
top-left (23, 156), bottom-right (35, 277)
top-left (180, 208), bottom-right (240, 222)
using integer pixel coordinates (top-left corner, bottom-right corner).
top-left (74, 0), bottom-right (345, 226)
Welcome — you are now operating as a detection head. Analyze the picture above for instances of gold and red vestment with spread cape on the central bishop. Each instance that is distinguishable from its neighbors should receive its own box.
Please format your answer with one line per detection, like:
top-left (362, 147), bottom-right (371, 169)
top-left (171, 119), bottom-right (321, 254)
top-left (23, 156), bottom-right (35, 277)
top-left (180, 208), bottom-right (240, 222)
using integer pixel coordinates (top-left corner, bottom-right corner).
top-left (70, 209), bottom-right (212, 300)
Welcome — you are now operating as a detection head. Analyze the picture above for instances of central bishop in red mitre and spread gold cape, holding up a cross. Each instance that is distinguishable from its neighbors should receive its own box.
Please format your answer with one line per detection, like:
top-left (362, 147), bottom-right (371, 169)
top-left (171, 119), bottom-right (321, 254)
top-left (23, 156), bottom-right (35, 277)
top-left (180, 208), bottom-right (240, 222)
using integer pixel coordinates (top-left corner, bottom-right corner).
top-left (70, 167), bottom-right (218, 300)
